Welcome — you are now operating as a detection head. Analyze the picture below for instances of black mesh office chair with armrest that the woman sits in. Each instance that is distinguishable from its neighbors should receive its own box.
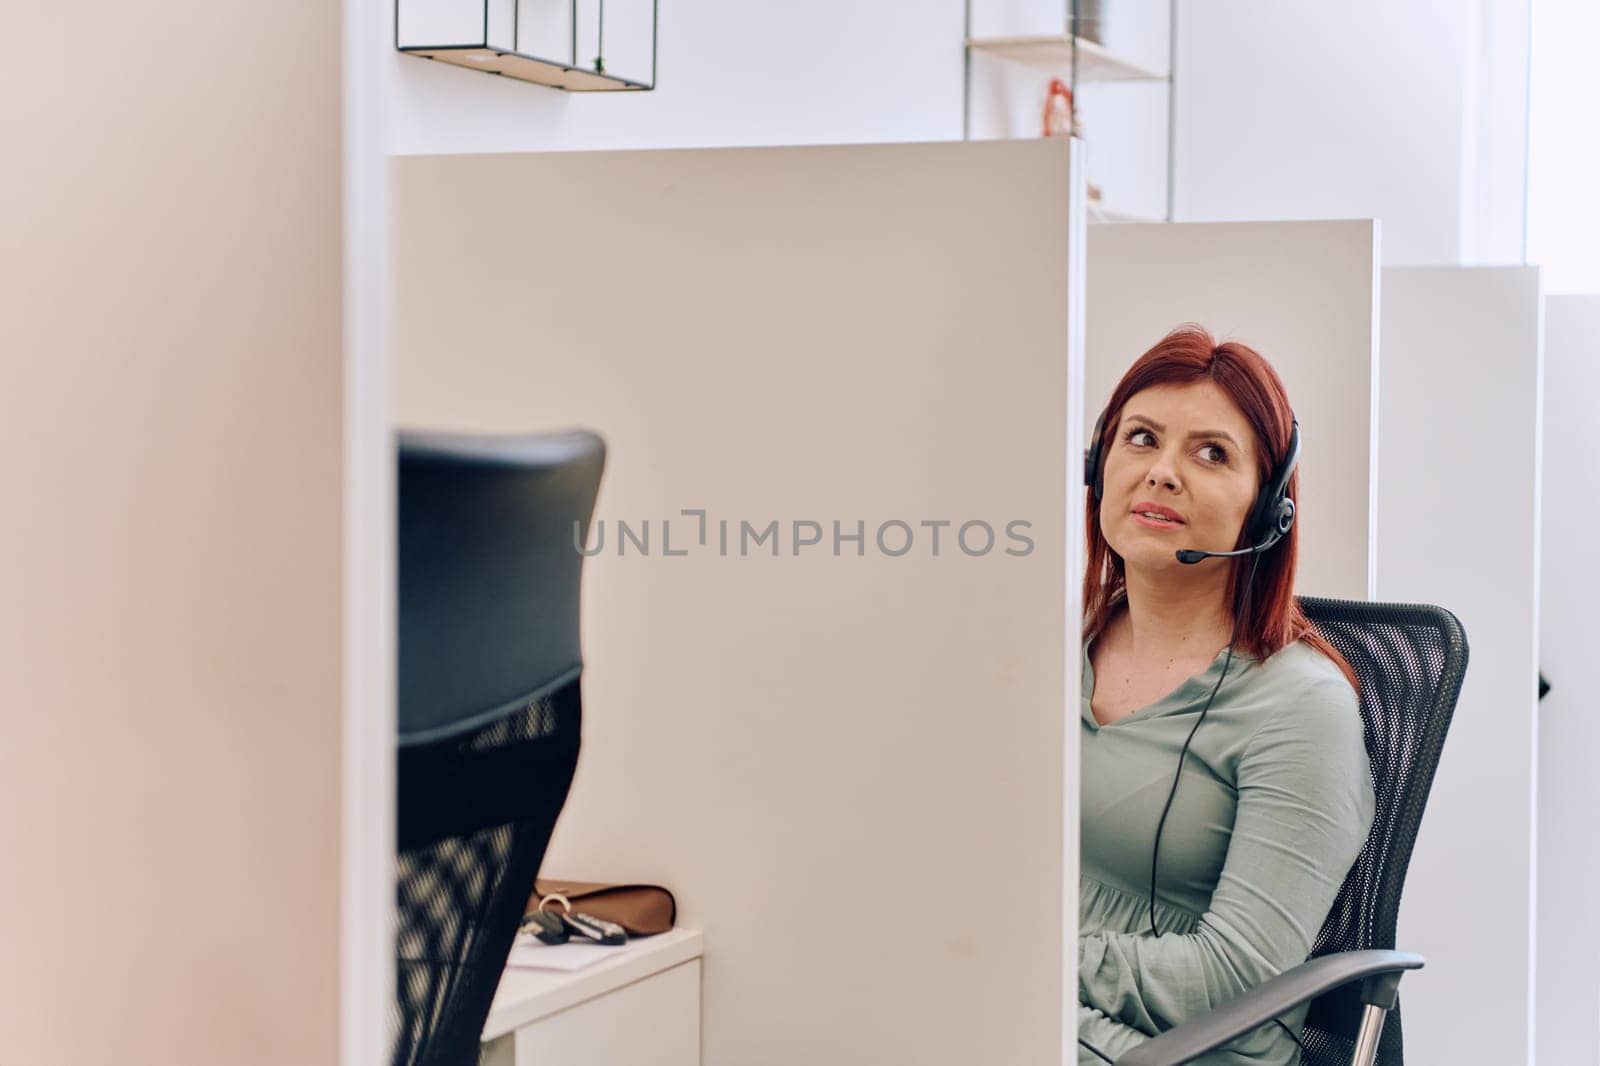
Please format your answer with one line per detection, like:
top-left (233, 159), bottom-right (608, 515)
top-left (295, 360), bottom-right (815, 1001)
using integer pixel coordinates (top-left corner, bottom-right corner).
top-left (1117, 597), bottom-right (1467, 1066)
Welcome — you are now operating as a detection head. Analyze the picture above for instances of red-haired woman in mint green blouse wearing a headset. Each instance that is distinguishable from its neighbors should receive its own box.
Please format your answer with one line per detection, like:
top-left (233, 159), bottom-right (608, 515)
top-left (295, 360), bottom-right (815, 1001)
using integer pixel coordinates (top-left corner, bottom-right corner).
top-left (1078, 327), bottom-right (1374, 1066)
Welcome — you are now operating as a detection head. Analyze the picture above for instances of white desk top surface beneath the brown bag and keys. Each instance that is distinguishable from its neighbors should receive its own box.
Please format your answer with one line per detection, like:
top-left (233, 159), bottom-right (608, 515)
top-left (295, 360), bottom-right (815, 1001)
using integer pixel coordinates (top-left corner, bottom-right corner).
top-left (483, 928), bottom-right (702, 1040)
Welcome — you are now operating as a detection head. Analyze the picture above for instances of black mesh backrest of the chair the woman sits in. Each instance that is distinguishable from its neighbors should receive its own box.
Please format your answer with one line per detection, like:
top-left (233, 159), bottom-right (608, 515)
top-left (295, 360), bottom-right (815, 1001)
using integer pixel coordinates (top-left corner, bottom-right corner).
top-left (1299, 597), bottom-right (1467, 1066)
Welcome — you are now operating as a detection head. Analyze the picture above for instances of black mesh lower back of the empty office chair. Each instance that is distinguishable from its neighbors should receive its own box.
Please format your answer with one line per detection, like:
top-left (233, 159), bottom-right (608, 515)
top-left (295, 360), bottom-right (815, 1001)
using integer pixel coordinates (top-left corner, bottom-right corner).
top-left (392, 679), bottom-right (582, 1066)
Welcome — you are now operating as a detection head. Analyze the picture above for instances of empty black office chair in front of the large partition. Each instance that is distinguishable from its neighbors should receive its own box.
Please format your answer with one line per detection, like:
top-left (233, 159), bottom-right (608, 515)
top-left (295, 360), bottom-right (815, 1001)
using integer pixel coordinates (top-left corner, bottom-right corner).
top-left (392, 432), bottom-right (605, 1066)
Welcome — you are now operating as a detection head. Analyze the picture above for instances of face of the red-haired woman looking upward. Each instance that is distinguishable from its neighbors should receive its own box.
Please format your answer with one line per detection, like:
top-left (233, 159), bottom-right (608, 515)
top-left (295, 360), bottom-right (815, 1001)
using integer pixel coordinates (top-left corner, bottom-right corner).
top-left (1099, 381), bottom-right (1258, 568)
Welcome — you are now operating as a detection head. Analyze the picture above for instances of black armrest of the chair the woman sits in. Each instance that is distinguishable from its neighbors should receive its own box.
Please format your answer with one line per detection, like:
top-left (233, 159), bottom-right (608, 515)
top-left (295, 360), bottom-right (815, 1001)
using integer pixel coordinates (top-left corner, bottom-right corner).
top-left (1117, 951), bottom-right (1422, 1066)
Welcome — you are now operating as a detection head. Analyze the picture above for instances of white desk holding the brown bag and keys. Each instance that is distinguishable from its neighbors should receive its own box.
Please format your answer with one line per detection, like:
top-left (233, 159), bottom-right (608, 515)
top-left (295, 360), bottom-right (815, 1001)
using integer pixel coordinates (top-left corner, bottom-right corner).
top-left (483, 928), bottom-right (702, 1066)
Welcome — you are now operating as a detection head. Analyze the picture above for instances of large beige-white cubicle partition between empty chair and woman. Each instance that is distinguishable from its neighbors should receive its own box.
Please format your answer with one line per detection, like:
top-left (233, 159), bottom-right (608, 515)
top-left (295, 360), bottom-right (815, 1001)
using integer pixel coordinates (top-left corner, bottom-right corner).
top-left (395, 142), bottom-right (1083, 1066)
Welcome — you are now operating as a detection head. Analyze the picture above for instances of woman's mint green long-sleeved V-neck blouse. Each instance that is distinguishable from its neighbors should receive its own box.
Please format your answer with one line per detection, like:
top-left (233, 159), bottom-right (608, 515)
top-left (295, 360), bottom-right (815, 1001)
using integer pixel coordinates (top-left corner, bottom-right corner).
top-left (1078, 642), bottom-right (1374, 1066)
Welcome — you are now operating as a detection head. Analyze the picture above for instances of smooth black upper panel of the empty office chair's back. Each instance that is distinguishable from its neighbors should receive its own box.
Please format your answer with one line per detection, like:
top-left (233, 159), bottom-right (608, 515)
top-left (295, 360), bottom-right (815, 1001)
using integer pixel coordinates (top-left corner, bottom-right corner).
top-left (395, 429), bottom-right (605, 744)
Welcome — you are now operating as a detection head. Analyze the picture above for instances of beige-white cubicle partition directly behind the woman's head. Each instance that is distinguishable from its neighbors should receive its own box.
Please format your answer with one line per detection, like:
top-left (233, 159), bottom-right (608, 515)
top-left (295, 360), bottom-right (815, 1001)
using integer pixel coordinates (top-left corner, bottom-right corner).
top-left (1085, 221), bottom-right (1378, 599)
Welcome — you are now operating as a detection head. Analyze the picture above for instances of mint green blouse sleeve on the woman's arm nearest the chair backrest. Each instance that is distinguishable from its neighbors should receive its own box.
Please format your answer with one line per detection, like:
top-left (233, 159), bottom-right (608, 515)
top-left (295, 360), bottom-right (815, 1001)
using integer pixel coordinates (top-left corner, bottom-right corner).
top-left (1078, 677), bottom-right (1374, 1034)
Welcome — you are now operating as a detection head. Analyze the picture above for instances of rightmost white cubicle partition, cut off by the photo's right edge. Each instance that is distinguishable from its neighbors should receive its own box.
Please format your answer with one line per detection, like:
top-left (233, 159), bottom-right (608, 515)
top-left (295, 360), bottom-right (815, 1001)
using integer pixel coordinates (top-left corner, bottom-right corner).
top-left (1534, 296), bottom-right (1600, 1066)
